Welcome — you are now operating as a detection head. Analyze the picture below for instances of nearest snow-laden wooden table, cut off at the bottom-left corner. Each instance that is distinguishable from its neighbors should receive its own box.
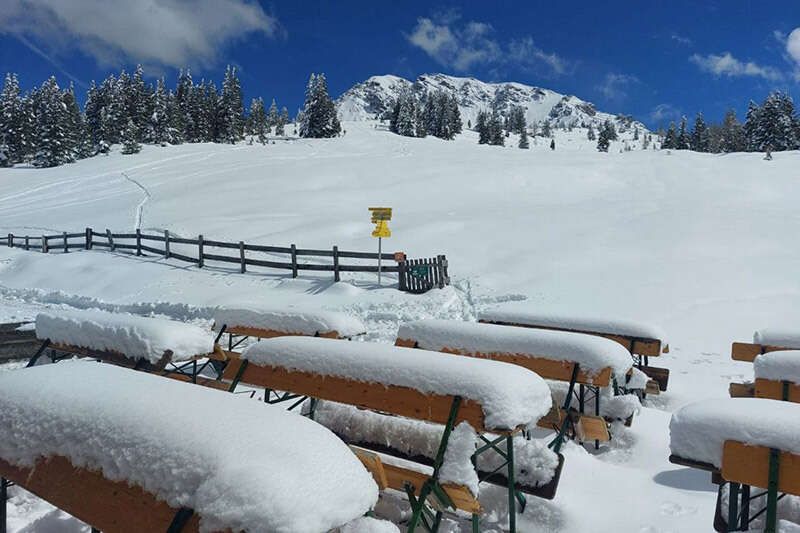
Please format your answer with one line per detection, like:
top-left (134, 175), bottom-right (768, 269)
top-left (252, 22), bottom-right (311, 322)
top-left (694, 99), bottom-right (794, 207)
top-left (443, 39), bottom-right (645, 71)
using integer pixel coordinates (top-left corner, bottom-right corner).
top-left (0, 361), bottom-right (377, 533)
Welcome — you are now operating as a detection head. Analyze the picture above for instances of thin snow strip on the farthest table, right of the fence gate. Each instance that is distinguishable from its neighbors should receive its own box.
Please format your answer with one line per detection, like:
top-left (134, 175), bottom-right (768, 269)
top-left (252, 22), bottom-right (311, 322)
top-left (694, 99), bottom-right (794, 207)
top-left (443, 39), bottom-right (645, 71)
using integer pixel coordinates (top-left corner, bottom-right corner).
top-left (478, 304), bottom-right (667, 344)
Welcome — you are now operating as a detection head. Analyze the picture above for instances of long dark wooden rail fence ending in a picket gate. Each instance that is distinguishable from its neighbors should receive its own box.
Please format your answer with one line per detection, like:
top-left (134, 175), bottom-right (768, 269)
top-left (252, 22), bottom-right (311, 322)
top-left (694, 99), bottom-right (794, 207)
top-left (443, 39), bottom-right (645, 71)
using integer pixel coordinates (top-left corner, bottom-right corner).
top-left (0, 228), bottom-right (450, 293)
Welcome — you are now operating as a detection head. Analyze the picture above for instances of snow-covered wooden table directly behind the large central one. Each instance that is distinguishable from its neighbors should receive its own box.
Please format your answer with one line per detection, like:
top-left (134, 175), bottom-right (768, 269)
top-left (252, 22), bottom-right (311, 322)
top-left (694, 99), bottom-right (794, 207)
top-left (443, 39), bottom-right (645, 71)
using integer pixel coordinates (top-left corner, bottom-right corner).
top-left (396, 320), bottom-right (635, 446)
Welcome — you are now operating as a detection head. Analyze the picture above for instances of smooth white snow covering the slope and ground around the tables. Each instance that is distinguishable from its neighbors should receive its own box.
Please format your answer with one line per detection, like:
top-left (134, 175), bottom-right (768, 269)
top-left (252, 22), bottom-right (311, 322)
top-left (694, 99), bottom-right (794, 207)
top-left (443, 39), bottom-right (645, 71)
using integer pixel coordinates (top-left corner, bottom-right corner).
top-left (0, 122), bottom-right (800, 533)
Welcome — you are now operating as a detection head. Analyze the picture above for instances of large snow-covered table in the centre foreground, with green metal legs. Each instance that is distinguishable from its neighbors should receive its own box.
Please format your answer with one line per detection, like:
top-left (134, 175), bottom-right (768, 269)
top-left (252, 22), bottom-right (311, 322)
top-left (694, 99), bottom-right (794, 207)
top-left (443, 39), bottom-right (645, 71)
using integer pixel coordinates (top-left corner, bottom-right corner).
top-left (223, 337), bottom-right (551, 531)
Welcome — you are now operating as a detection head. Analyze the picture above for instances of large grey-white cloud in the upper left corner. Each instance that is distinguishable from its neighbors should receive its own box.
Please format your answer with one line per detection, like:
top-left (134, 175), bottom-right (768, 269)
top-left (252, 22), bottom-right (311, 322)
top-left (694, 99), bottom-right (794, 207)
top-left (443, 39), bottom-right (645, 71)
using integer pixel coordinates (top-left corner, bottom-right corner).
top-left (0, 0), bottom-right (279, 67)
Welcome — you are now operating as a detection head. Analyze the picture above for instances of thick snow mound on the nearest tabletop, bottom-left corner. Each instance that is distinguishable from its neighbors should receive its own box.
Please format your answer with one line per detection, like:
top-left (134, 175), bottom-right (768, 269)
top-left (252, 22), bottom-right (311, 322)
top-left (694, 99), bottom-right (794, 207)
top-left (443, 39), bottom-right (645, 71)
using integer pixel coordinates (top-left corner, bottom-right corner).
top-left (0, 361), bottom-right (378, 533)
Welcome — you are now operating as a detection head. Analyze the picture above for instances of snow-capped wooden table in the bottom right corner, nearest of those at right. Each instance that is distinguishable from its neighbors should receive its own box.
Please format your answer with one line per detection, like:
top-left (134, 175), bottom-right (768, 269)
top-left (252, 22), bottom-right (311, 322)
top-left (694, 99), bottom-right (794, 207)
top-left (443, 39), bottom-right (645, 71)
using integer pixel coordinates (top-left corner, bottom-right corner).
top-left (669, 398), bottom-right (800, 532)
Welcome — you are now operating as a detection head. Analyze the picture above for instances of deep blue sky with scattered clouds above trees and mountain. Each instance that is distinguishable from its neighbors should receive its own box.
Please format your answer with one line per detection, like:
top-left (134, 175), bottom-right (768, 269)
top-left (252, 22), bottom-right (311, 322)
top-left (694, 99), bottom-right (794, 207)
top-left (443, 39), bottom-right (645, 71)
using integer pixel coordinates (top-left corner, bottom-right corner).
top-left (0, 0), bottom-right (800, 127)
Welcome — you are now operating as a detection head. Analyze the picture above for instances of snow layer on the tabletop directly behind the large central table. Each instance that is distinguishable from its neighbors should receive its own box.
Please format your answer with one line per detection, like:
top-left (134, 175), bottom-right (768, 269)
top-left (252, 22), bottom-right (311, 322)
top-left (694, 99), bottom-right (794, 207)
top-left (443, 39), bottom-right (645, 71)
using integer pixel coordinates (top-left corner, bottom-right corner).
top-left (397, 319), bottom-right (633, 383)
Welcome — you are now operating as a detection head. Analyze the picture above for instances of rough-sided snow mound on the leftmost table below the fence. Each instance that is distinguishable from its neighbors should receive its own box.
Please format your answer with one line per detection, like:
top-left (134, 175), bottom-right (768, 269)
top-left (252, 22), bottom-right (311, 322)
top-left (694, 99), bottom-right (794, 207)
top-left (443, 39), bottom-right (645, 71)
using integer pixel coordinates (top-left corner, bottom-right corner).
top-left (36, 309), bottom-right (214, 363)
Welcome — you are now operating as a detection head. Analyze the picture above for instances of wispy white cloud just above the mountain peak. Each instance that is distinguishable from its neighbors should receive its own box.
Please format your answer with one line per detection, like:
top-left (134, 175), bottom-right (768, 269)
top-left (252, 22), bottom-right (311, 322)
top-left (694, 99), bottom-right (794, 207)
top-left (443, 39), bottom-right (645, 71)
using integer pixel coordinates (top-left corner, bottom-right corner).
top-left (406, 13), bottom-right (567, 74)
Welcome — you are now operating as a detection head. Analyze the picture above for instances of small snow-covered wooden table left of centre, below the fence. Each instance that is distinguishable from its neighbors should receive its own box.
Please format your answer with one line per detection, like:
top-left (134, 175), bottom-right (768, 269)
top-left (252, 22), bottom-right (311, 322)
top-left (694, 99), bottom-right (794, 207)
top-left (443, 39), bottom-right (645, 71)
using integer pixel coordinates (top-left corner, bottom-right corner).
top-left (209, 305), bottom-right (367, 350)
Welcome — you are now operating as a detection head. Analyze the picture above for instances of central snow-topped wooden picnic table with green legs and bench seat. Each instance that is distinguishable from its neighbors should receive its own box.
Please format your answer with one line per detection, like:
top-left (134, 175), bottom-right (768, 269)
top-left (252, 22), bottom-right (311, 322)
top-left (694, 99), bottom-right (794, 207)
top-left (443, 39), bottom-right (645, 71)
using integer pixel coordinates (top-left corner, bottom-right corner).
top-left (223, 337), bottom-right (560, 531)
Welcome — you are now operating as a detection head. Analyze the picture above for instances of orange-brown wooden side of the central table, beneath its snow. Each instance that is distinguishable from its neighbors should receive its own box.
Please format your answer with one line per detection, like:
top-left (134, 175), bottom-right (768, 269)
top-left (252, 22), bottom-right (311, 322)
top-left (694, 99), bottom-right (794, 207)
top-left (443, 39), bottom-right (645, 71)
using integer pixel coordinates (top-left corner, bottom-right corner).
top-left (224, 362), bottom-right (490, 432)
